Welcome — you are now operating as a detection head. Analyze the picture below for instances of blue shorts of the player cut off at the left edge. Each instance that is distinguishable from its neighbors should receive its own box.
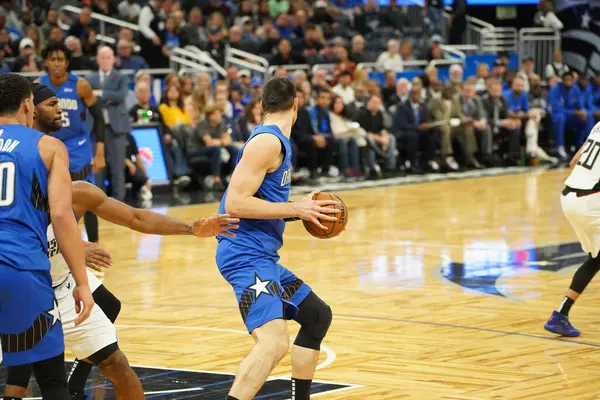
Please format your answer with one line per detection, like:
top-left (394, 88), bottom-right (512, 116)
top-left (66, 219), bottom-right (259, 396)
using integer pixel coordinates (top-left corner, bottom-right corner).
top-left (0, 265), bottom-right (65, 366)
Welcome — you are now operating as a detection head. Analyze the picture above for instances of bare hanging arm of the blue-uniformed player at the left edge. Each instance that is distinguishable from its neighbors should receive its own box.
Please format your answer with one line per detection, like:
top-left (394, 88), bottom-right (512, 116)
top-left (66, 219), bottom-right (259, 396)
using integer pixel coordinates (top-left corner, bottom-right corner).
top-left (39, 136), bottom-right (94, 325)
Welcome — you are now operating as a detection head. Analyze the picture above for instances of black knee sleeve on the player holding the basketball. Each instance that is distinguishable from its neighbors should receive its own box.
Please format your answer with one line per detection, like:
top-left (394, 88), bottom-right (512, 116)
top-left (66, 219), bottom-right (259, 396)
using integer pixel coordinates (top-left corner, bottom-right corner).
top-left (294, 292), bottom-right (333, 350)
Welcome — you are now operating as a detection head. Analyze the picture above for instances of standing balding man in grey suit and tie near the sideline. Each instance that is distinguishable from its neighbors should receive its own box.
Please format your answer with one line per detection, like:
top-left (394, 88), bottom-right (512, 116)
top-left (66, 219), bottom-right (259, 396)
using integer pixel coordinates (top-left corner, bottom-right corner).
top-left (88, 46), bottom-right (131, 201)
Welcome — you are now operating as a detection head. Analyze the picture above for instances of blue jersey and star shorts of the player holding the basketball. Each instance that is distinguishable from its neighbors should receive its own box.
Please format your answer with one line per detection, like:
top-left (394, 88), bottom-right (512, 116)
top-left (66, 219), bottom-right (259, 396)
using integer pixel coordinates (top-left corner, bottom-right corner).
top-left (216, 125), bottom-right (311, 332)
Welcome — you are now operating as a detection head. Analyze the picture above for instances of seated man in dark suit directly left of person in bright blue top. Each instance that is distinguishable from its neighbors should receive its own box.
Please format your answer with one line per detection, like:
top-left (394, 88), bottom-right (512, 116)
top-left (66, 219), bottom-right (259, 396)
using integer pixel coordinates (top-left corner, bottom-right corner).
top-left (481, 79), bottom-right (522, 165)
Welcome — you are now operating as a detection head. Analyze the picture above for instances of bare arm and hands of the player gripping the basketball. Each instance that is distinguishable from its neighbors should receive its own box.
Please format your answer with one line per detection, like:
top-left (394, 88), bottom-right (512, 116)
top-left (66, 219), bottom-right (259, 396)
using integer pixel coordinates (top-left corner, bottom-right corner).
top-left (225, 134), bottom-right (337, 226)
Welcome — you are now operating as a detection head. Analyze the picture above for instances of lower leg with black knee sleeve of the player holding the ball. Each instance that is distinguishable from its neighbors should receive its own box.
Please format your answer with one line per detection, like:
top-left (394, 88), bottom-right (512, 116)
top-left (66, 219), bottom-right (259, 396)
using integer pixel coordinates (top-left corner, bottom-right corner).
top-left (292, 292), bottom-right (333, 400)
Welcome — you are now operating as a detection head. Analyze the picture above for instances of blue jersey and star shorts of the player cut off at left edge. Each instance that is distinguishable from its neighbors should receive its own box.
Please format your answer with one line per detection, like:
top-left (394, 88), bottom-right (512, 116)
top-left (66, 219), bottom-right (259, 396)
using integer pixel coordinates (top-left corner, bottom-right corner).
top-left (0, 125), bottom-right (64, 366)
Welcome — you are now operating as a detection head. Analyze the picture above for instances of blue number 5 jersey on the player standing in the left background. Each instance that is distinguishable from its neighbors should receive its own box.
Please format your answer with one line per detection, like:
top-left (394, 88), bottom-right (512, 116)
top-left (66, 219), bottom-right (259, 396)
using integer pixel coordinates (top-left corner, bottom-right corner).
top-left (40, 73), bottom-right (93, 172)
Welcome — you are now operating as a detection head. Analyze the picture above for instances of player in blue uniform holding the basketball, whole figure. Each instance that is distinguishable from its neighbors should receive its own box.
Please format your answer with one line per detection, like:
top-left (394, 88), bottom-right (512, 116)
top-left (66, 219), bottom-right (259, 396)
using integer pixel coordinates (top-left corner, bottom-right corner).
top-left (216, 78), bottom-right (337, 400)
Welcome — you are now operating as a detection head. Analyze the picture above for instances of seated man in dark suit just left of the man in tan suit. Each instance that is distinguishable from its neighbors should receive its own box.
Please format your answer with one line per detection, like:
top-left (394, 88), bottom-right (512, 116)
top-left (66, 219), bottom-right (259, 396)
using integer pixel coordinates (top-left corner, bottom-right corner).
top-left (392, 88), bottom-right (440, 173)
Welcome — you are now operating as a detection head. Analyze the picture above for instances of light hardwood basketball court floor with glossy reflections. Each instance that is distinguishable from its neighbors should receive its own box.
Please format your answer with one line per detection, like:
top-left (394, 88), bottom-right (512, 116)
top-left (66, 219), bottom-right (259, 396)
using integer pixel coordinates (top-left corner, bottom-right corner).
top-left (84, 170), bottom-right (600, 400)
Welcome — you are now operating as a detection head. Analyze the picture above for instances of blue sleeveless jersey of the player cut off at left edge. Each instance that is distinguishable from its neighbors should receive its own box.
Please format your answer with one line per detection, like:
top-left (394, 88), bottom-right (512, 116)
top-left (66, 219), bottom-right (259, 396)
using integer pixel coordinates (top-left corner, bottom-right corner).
top-left (0, 125), bottom-right (50, 271)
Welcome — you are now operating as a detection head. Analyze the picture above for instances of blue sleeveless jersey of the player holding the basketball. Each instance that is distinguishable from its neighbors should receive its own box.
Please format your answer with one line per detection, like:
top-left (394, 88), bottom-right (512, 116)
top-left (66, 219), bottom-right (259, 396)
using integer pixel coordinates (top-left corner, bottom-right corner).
top-left (217, 125), bottom-right (292, 254)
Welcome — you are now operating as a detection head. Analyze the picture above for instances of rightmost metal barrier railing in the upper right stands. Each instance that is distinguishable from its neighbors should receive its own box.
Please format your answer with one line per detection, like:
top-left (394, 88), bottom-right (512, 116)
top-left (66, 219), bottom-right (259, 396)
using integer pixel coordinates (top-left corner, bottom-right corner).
top-left (519, 28), bottom-right (561, 77)
